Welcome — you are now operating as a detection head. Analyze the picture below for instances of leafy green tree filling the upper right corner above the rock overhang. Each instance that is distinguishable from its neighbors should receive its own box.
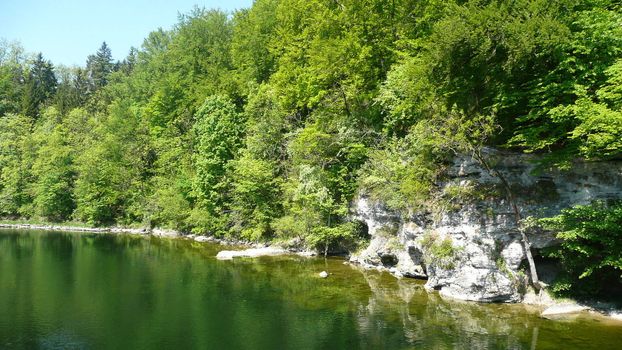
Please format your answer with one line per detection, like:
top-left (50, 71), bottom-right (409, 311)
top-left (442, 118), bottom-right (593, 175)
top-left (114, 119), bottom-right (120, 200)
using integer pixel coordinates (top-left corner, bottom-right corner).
top-left (510, 6), bottom-right (622, 165)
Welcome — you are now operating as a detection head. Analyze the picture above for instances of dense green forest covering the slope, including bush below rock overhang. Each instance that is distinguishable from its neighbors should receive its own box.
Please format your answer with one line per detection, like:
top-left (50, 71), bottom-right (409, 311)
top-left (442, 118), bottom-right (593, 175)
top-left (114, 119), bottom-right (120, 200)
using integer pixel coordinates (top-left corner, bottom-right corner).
top-left (0, 0), bottom-right (622, 296)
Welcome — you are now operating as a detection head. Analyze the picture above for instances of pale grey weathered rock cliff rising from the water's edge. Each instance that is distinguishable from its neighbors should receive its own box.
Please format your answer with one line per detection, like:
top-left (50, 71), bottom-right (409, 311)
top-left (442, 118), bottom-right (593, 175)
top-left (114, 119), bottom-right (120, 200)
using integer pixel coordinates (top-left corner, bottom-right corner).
top-left (350, 150), bottom-right (622, 302)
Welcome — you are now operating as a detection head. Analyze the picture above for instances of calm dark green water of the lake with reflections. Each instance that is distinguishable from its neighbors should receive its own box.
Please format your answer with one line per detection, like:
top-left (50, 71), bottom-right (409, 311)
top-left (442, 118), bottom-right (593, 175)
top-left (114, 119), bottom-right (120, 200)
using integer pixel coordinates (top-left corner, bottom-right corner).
top-left (0, 230), bottom-right (622, 349)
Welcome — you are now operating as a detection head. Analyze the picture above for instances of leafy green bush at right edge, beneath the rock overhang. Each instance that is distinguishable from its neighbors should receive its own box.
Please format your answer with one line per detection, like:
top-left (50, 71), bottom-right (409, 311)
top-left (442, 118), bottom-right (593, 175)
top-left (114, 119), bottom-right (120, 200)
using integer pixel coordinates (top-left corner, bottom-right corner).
top-left (540, 202), bottom-right (622, 297)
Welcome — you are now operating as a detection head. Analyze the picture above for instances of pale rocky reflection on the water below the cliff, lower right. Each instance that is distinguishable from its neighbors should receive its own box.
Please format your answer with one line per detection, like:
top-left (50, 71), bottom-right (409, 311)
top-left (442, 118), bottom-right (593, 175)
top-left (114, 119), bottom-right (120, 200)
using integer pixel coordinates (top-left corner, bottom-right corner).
top-left (348, 264), bottom-right (622, 349)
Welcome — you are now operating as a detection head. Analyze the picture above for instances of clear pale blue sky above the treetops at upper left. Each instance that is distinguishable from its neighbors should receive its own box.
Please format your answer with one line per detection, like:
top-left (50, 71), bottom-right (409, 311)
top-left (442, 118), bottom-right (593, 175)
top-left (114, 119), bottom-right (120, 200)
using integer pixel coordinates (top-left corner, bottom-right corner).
top-left (0, 0), bottom-right (253, 65)
